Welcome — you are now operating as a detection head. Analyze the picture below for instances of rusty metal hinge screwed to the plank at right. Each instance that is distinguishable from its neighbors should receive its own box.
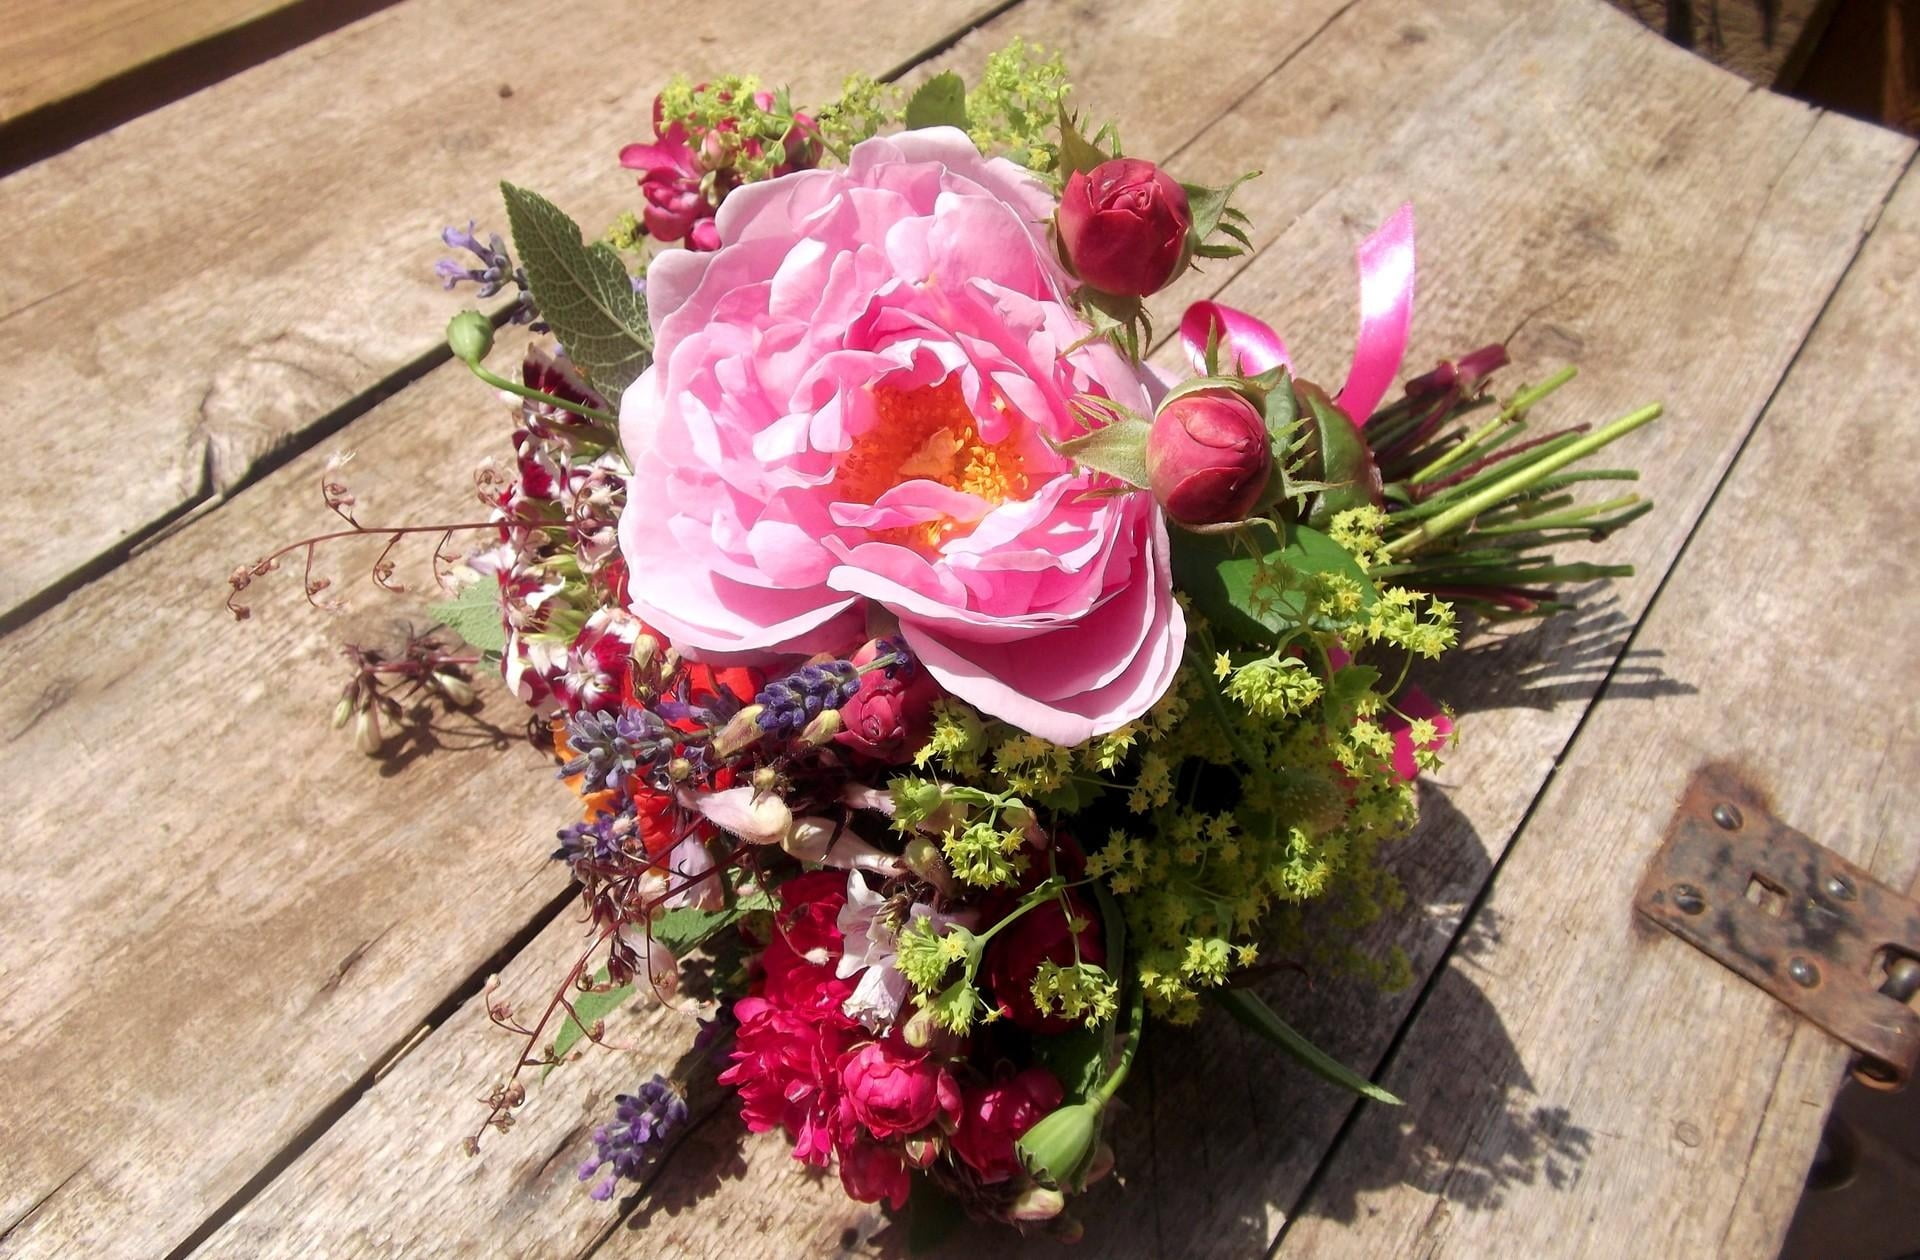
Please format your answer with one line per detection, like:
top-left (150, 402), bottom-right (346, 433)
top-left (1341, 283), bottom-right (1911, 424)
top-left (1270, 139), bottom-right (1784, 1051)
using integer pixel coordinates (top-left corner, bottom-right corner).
top-left (1634, 764), bottom-right (1920, 1089)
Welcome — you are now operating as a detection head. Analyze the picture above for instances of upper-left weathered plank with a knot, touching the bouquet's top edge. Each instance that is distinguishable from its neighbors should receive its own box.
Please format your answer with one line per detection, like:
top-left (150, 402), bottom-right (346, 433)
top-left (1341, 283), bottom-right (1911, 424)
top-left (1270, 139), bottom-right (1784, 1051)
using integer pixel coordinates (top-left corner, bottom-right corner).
top-left (0, 0), bottom-right (993, 624)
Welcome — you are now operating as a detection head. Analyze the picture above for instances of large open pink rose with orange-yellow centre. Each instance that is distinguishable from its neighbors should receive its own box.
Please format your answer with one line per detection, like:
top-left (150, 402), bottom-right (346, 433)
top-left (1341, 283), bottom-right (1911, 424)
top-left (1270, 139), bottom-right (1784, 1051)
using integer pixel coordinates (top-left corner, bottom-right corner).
top-left (620, 127), bottom-right (1187, 743)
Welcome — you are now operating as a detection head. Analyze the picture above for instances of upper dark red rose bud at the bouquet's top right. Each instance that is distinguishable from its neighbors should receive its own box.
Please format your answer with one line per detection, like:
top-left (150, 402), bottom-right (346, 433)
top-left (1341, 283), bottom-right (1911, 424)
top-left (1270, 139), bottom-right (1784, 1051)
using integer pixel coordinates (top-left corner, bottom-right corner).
top-left (1054, 158), bottom-right (1194, 298)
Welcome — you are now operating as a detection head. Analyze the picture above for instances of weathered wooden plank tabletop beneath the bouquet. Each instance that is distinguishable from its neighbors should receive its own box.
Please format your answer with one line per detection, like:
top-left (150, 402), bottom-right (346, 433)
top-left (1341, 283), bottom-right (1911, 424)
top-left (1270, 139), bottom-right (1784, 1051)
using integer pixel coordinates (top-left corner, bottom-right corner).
top-left (0, 0), bottom-right (1920, 1260)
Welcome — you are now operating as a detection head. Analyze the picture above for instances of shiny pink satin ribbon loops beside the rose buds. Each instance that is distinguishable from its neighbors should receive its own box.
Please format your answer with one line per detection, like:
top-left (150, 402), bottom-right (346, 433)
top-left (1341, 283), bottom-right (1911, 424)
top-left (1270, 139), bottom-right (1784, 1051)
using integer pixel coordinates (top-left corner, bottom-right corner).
top-left (1181, 204), bottom-right (1415, 424)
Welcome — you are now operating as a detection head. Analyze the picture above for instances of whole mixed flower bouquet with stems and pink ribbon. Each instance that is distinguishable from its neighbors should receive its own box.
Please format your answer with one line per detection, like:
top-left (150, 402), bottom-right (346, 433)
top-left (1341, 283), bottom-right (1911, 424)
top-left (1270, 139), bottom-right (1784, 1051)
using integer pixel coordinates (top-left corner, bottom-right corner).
top-left (230, 44), bottom-right (1659, 1237)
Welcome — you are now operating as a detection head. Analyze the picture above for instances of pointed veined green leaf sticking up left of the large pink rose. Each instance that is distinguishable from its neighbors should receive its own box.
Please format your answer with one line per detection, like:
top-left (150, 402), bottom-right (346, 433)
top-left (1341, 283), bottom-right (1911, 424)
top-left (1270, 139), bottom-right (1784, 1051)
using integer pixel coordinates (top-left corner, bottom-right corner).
top-left (499, 182), bottom-right (653, 401)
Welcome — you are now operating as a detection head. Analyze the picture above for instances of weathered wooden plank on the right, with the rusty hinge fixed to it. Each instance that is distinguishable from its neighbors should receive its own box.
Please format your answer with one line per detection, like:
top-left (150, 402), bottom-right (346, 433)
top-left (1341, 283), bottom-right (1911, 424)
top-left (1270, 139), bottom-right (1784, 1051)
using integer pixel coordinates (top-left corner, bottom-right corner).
top-left (1281, 154), bottom-right (1920, 1256)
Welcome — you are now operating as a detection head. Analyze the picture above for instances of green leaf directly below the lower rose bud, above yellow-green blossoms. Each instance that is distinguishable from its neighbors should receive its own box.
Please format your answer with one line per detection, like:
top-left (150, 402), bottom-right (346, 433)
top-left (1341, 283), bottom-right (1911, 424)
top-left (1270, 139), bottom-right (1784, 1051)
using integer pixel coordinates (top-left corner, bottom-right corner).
top-left (1173, 524), bottom-right (1379, 643)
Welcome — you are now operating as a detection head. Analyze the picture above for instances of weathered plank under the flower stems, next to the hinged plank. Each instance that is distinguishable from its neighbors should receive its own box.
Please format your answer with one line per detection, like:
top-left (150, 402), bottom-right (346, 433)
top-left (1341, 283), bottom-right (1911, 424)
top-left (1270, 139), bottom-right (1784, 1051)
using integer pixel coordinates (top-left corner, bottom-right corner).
top-left (172, 0), bottom-right (1907, 1256)
